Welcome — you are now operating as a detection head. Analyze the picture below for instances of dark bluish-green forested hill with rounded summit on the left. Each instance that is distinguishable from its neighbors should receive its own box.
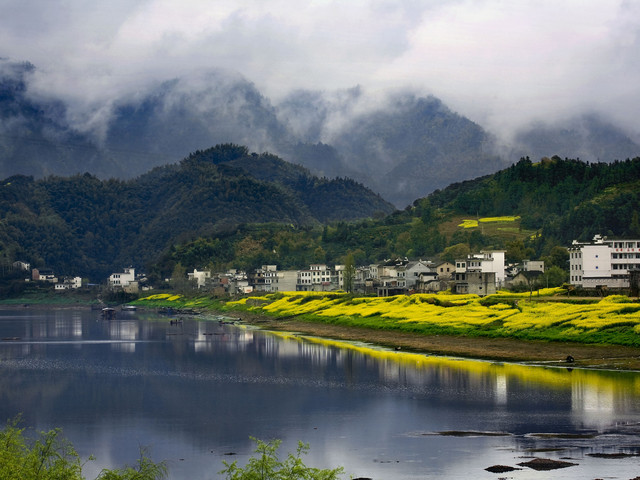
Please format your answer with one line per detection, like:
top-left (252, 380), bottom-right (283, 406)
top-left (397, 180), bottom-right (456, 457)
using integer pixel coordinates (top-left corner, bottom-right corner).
top-left (0, 144), bottom-right (393, 280)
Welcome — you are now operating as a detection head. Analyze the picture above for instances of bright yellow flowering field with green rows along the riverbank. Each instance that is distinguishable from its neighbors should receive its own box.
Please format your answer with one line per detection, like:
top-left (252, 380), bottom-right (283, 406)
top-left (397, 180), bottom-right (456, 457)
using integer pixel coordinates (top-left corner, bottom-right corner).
top-left (229, 289), bottom-right (640, 346)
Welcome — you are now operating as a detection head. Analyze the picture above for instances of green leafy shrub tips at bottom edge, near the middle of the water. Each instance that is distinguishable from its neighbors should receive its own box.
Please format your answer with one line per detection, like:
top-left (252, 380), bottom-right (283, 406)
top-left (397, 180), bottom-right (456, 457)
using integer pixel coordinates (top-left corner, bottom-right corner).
top-left (220, 438), bottom-right (344, 480)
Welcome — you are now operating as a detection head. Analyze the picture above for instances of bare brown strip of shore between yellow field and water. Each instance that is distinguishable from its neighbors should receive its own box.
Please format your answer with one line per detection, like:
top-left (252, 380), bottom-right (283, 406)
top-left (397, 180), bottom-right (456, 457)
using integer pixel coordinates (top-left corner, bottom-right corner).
top-left (230, 311), bottom-right (640, 371)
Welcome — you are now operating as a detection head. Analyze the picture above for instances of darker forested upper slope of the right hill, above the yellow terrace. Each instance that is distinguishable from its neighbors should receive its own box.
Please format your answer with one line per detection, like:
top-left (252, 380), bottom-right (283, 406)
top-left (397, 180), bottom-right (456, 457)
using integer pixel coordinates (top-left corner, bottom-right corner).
top-left (428, 157), bottom-right (640, 248)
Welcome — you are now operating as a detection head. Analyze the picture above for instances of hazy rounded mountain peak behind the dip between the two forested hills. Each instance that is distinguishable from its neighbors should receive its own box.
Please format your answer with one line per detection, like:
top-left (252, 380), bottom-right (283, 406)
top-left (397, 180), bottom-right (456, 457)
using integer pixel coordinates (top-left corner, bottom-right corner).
top-left (288, 93), bottom-right (506, 207)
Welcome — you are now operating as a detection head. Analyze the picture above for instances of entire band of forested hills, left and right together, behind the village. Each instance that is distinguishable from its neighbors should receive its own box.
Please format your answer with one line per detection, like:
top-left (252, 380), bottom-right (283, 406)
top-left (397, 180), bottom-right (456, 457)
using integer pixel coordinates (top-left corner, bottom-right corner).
top-left (0, 150), bottom-right (640, 280)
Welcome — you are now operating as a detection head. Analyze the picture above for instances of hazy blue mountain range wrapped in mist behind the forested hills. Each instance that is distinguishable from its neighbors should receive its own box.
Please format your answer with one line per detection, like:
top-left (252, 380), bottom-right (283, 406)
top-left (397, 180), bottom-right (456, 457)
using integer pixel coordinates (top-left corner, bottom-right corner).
top-left (0, 60), bottom-right (640, 208)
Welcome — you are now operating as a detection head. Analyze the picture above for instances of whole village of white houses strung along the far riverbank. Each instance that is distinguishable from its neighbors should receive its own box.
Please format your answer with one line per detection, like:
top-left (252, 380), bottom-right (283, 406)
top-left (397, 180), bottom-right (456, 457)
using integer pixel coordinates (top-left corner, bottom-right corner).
top-left (13, 235), bottom-right (640, 296)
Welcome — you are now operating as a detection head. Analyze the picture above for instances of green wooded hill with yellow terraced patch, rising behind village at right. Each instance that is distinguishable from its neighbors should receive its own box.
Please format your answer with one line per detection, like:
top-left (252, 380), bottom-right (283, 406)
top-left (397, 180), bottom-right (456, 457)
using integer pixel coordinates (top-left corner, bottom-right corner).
top-left (155, 157), bottom-right (640, 275)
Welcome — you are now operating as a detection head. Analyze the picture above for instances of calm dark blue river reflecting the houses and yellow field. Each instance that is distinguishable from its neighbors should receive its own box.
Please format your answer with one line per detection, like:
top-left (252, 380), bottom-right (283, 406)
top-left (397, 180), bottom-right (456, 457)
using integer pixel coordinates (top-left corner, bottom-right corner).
top-left (0, 307), bottom-right (640, 480)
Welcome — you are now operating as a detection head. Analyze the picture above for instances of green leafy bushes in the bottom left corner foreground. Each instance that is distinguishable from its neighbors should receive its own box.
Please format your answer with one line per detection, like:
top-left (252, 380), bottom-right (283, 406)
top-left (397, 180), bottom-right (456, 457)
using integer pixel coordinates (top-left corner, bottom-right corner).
top-left (0, 418), bottom-right (167, 480)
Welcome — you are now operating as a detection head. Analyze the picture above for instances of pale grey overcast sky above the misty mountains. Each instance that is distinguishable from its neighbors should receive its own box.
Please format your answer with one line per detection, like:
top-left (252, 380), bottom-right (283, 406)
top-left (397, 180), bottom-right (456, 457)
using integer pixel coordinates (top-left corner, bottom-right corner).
top-left (0, 0), bottom-right (640, 138)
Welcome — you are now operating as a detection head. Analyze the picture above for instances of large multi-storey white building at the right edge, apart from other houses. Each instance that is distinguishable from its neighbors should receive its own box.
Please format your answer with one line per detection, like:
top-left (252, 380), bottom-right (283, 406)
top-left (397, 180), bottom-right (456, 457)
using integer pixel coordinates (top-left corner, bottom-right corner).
top-left (569, 235), bottom-right (640, 288)
